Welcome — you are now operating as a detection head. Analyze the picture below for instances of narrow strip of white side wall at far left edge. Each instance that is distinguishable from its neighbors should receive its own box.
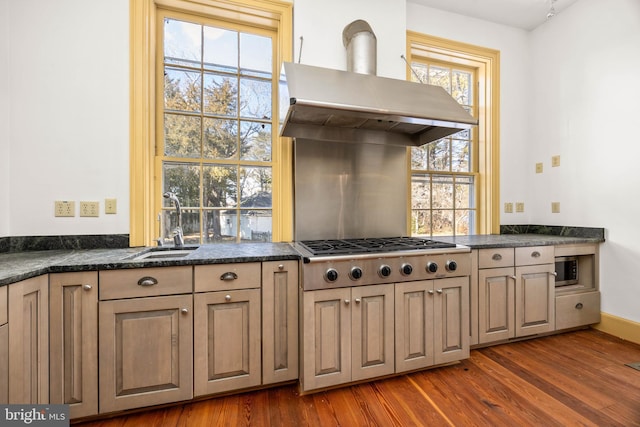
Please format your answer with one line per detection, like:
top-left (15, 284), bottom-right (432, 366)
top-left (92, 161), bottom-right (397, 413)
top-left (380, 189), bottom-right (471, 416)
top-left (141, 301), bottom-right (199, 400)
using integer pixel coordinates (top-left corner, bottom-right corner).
top-left (0, 0), bottom-right (10, 237)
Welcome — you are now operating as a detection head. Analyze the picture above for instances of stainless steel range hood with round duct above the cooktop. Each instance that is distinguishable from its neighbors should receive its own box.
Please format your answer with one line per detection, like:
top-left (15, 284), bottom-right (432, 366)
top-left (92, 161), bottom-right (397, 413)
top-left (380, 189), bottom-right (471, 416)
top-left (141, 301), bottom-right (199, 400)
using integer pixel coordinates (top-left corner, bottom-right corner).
top-left (280, 21), bottom-right (478, 146)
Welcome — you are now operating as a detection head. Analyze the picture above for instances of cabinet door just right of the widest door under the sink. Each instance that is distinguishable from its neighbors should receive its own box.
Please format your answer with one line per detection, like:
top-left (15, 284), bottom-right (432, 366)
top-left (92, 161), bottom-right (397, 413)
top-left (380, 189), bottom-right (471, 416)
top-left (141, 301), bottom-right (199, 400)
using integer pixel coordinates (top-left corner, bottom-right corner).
top-left (194, 289), bottom-right (261, 396)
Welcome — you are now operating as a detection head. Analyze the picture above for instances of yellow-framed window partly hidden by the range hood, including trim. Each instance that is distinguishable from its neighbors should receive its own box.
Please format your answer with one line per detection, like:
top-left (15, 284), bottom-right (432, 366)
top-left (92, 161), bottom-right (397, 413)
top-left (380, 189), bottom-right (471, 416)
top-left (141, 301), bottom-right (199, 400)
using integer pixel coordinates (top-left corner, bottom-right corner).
top-left (407, 32), bottom-right (500, 236)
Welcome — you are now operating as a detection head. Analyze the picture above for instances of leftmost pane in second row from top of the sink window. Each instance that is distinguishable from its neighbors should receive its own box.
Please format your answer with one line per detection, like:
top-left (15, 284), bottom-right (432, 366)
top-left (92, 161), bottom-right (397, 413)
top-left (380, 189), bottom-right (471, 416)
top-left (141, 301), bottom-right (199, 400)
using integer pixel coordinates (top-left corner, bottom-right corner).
top-left (164, 68), bottom-right (201, 112)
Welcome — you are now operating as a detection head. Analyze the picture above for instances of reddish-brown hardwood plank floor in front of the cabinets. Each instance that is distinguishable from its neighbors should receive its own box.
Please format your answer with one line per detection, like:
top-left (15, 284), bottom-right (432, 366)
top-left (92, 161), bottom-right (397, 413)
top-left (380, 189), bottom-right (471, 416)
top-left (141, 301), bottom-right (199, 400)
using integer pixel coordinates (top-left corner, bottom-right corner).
top-left (77, 329), bottom-right (640, 427)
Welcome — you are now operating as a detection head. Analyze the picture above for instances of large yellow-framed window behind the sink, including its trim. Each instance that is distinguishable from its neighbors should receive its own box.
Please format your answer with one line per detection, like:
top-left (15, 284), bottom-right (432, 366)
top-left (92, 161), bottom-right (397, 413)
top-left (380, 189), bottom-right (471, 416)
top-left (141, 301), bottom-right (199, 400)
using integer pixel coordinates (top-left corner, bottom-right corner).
top-left (130, 0), bottom-right (292, 246)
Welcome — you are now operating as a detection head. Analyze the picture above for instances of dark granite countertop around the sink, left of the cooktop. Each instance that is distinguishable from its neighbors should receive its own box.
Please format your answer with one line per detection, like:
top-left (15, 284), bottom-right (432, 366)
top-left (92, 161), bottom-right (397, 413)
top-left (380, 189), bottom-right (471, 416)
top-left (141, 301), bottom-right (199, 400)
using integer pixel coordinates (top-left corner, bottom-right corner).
top-left (0, 243), bottom-right (300, 286)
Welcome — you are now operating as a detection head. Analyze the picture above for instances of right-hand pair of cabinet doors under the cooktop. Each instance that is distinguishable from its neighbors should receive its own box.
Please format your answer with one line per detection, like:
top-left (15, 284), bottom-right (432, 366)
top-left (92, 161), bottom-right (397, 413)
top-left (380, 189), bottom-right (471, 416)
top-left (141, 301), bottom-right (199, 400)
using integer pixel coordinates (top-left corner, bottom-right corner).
top-left (395, 277), bottom-right (469, 372)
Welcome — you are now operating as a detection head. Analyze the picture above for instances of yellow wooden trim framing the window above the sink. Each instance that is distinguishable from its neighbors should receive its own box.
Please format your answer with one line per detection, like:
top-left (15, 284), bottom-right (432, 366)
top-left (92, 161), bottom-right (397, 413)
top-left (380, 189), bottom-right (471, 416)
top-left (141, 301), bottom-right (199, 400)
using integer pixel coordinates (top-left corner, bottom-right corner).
top-left (129, 0), bottom-right (293, 247)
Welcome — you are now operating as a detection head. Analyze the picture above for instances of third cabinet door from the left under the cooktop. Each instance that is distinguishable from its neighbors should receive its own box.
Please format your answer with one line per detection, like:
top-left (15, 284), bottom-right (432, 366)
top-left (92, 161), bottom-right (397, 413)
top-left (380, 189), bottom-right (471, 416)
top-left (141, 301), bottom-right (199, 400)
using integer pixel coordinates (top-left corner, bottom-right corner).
top-left (395, 280), bottom-right (434, 372)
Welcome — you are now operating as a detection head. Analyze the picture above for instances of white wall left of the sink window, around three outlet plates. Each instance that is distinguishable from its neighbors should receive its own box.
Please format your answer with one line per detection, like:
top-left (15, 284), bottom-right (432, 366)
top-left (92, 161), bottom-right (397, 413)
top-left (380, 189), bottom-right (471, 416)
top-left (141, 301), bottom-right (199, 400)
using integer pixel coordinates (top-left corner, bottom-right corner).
top-left (0, 0), bottom-right (129, 236)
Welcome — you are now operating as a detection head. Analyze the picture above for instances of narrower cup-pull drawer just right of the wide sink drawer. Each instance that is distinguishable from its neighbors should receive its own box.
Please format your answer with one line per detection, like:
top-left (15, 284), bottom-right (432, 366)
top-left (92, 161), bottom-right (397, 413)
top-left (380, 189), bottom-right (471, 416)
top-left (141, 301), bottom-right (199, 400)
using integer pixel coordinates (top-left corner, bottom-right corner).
top-left (194, 262), bottom-right (262, 292)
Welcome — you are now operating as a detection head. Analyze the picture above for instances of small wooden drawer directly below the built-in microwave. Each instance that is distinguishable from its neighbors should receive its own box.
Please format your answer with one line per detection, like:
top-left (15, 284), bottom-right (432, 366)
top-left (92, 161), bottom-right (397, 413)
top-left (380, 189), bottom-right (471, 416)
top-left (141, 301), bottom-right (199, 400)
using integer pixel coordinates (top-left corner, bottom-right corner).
top-left (556, 292), bottom-right (600, 330)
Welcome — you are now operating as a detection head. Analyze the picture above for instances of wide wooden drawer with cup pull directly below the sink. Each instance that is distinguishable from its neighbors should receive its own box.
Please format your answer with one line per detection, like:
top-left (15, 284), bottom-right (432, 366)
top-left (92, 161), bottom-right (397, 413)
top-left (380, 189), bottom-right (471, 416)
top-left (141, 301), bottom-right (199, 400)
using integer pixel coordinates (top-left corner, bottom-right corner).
top-left (99, 265), bottom-right (192, 300)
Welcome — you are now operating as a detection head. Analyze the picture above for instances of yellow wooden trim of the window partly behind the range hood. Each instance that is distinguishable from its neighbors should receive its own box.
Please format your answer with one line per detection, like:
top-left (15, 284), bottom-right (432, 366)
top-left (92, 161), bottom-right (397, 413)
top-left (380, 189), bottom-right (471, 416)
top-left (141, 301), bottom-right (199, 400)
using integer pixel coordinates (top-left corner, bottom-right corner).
top-left (406, 31), bottom-right (500, 234)
